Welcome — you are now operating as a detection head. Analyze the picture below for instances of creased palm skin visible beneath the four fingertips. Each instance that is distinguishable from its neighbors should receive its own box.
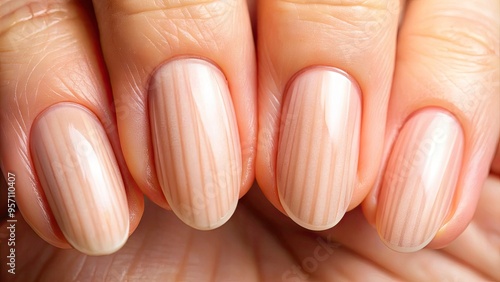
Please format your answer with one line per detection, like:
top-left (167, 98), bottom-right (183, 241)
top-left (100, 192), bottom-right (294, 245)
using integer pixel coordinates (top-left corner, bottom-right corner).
top-left (0, 174), bottom-right (500, 281)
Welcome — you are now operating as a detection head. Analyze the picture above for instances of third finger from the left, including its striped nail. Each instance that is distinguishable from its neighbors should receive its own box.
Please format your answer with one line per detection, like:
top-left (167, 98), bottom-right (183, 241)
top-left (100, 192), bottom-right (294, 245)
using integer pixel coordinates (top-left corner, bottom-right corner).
top-left (256, 0), bottom-right (399, 229)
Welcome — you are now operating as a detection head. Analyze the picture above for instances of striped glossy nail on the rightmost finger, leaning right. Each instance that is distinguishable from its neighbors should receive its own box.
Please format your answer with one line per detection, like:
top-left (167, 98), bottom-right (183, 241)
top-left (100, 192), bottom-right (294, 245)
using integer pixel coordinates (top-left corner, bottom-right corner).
top-left (376, 108), bottom-right (464, 252)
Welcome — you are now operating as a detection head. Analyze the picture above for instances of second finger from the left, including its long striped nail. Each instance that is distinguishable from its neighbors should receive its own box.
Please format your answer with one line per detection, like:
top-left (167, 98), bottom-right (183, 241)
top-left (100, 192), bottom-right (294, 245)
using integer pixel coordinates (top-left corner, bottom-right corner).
top-left (94, 0), bottom-right (256, 229)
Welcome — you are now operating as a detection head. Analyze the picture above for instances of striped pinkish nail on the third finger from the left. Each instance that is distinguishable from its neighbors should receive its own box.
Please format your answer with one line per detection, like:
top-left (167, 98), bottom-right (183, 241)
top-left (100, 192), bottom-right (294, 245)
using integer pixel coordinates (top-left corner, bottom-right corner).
top-left (277, 67), bottom-right (361, 230)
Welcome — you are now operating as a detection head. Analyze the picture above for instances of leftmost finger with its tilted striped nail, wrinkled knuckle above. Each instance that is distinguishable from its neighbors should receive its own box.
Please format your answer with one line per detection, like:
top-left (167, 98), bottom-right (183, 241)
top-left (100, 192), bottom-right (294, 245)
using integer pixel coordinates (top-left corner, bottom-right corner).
top-left (0, 1), bottom-right (143, 255)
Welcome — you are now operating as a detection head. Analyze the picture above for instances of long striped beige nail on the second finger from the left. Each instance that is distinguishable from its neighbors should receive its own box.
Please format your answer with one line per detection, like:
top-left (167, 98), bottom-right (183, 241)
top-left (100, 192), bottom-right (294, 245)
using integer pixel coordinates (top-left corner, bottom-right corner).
top-left (149, 58), bottom-right (241, 230)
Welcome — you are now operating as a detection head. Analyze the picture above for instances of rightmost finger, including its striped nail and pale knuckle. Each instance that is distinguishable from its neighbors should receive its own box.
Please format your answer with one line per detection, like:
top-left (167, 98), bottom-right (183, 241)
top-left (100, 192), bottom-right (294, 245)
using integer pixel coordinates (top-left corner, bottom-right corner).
top-left (365, 0), bottom-right (500, 251)
